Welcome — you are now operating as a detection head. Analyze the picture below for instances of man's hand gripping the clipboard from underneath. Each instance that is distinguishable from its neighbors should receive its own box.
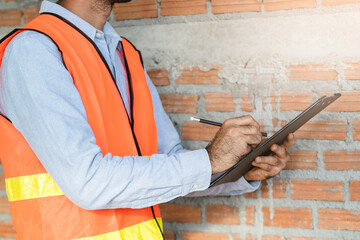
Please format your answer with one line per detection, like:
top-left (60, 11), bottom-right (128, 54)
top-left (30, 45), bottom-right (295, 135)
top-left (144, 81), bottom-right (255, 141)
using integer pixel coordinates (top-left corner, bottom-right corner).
top-left (244, 134), bottom-right (295, 181)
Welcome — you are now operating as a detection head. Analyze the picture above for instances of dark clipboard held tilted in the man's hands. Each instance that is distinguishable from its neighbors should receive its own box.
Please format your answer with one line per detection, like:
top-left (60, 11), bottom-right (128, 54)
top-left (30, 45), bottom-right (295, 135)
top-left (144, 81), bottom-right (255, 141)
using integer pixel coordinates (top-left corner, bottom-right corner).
top-left (210, 93), bottom-right (341, 187)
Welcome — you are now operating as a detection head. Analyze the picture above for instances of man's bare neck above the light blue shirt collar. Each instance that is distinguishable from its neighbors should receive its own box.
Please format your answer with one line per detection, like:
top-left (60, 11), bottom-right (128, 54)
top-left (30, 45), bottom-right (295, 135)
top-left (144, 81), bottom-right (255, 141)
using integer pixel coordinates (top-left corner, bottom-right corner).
top-left (57, 0), bottom-right (112, 31)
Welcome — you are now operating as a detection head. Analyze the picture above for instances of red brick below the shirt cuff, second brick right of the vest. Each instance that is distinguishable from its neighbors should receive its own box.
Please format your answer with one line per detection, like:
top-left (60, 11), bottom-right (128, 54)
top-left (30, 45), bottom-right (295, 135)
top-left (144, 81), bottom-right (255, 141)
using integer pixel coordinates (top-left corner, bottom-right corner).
top-left (206, 205), bottom-right (240, 225)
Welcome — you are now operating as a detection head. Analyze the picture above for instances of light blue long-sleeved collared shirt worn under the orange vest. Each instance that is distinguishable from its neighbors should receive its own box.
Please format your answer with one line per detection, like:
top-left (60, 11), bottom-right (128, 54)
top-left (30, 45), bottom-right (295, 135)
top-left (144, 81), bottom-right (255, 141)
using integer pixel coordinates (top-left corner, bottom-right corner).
top-left (0, 1), bottom-right (259, 209)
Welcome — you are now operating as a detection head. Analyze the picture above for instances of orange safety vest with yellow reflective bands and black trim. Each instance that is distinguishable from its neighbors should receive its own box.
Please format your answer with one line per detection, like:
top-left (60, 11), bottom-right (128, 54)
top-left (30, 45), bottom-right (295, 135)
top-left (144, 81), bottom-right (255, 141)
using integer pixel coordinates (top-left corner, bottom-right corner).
top-left (0, 13), bottom-right (163, 240)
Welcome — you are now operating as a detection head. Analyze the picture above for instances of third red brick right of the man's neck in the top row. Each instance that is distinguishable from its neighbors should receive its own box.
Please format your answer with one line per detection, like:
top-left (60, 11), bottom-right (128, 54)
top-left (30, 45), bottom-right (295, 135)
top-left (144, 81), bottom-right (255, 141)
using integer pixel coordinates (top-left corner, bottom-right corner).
top-left (211, 0), bottom-right (261, 14)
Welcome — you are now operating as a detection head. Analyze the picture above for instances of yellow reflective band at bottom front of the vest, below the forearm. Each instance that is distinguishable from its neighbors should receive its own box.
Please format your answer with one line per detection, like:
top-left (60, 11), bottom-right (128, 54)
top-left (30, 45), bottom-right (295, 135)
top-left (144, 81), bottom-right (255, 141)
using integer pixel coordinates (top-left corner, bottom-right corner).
top-left (73, 218), bottom-right (163, 240)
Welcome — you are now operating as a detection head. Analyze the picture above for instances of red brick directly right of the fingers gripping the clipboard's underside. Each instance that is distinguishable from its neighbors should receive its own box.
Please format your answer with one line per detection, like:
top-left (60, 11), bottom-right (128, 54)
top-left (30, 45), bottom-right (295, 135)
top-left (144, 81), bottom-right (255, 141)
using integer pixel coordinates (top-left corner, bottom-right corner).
top-left (285, 151), bottom-right (317, 170)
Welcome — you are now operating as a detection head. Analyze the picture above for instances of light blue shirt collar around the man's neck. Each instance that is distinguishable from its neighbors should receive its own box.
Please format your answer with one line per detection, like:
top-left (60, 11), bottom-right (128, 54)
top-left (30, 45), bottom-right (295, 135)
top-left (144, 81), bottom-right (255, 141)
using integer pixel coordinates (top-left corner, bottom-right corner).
top-left (40, 0), bottom-right (121, 42)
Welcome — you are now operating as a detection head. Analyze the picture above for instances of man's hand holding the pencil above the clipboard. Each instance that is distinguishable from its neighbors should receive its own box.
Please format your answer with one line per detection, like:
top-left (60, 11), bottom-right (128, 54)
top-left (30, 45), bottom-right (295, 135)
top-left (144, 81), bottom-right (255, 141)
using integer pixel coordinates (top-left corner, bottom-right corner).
top-left (206, 116), bottom-right (262, 174)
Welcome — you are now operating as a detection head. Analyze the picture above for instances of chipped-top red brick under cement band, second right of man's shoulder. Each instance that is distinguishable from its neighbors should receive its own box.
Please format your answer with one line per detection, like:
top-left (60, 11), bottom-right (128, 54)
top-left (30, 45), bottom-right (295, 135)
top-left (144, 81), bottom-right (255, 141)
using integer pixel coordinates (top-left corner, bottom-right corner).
top-left (176, 66), bottom-right (221, 84)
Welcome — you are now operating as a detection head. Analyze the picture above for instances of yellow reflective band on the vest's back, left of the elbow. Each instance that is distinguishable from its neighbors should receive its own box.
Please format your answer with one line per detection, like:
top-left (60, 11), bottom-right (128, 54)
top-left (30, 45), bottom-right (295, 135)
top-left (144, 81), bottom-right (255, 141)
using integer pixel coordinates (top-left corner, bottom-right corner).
top-left (5, 173), bottom-right (64, 202)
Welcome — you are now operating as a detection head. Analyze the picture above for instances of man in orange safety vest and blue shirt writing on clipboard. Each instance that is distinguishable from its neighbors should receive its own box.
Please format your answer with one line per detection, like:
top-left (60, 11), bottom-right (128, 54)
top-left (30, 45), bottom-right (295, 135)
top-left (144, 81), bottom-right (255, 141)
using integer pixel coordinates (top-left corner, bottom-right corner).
top-left (0, 0), bottom-right (294, 239)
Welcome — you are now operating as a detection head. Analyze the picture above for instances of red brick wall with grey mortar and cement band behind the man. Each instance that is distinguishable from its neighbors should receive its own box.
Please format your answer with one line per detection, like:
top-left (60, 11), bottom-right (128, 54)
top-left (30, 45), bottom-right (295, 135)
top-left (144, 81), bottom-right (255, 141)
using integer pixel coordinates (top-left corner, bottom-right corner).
top-left (0, 0), bottom-right (360, 240)
